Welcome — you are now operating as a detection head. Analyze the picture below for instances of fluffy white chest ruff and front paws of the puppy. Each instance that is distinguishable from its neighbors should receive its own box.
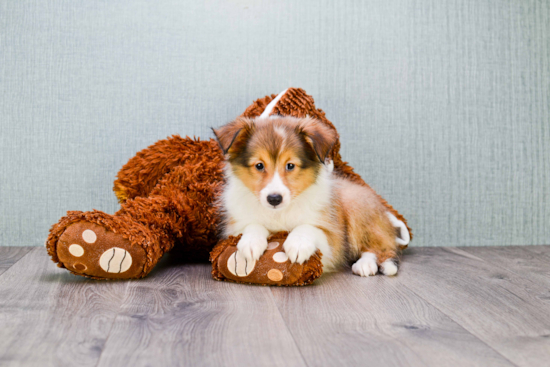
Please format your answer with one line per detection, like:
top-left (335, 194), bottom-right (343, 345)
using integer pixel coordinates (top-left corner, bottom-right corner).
top-left (222, 166), bottom-right (334, 269)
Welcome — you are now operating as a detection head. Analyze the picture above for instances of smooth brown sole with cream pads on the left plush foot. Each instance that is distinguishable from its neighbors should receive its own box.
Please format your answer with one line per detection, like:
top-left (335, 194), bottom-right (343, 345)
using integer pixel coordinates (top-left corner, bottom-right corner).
top-left (57, 221), bottom-right (147, 279)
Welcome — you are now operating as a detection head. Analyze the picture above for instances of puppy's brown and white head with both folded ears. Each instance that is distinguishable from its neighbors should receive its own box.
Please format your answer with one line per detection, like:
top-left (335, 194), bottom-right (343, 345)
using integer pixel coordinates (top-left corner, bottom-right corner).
top-left (214, 117), bottom-right (337, 210)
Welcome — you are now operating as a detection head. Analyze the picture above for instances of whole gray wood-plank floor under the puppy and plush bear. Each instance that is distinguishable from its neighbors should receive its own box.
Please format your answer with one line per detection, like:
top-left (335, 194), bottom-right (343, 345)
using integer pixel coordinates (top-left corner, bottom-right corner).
top-left (0, 246), bottom-right (550, 367)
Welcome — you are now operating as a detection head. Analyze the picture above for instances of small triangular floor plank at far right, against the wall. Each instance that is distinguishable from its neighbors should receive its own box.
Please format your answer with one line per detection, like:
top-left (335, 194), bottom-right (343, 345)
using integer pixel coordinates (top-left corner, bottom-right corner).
top-left (460, 246), bottom-right (550, 288)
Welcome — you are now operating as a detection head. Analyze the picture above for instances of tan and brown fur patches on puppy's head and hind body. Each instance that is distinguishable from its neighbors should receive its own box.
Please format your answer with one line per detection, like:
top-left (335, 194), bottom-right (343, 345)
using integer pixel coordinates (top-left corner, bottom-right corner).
top-left (219, 117), bottom-right (398, 267)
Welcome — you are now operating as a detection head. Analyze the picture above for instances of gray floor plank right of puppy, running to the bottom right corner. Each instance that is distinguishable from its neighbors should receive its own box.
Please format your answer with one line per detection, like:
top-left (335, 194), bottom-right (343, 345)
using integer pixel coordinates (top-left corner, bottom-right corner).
top-left (396, 247), bottom-right (550, 366)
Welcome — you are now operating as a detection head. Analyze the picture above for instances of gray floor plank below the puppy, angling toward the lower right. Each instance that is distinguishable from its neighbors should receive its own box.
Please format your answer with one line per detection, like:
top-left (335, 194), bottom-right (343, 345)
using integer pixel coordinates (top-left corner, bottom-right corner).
top-left (272, 269), bottom-right (513, 367)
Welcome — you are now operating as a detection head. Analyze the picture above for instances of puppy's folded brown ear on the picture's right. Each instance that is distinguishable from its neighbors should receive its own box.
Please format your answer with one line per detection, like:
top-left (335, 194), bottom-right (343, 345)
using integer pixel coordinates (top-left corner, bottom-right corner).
top-left (297, 118), bottom-right (338, 164)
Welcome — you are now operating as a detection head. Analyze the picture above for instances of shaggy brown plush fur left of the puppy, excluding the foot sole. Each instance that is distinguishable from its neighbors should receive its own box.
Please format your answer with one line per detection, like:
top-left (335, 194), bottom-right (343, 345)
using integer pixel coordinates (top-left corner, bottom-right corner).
top-left (46, 136), bottom-right (223, 276)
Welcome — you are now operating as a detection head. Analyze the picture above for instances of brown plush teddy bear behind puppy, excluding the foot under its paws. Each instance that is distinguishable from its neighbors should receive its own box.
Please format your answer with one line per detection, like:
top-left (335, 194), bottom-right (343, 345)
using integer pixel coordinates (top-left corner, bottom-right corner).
top-left (46, 88), bottom-right (410, 279)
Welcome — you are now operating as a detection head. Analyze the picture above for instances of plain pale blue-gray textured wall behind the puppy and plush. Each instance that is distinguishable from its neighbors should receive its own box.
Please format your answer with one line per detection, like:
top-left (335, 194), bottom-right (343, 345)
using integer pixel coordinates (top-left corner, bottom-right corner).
top-left (0, 0), bottom-right (550, 246)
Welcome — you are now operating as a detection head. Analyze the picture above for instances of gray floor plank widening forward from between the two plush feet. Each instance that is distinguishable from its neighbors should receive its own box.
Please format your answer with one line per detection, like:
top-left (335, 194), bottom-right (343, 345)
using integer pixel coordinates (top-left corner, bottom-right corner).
top-left (95, 258), bottom-right (305, 366)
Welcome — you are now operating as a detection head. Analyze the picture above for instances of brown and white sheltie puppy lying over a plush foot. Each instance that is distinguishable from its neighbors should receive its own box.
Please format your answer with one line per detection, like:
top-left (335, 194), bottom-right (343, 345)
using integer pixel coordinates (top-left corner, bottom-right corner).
top-left (214, 117), bottom-right (398, 276)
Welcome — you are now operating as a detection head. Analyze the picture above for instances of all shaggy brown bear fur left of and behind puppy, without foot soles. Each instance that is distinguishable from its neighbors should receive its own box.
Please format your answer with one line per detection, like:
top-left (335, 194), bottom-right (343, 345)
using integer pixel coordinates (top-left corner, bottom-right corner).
top-left (46, 88), bottom-right (406, 277)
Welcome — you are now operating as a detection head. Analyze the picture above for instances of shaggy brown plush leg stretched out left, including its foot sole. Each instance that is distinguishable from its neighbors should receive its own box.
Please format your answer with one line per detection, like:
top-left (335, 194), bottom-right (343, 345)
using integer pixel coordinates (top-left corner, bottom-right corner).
top-left (46, 150), bottom-right (223, 279)
